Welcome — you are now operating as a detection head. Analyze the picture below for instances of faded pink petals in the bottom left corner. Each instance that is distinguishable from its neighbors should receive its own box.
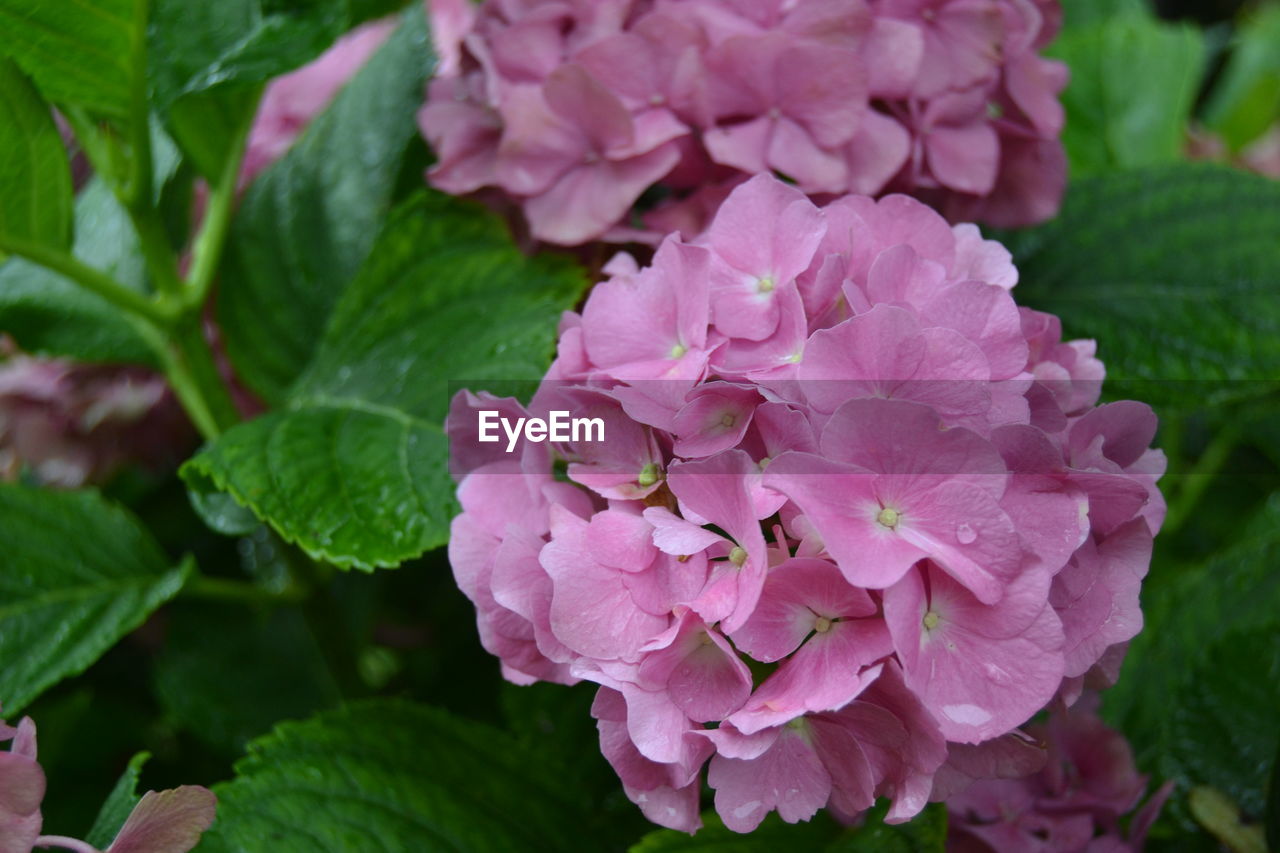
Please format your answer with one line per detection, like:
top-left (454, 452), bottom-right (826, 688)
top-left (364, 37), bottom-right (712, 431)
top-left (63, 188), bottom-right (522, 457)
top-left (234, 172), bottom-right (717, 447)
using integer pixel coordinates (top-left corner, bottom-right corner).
top-left (0, 701), bottom-right (218, 853)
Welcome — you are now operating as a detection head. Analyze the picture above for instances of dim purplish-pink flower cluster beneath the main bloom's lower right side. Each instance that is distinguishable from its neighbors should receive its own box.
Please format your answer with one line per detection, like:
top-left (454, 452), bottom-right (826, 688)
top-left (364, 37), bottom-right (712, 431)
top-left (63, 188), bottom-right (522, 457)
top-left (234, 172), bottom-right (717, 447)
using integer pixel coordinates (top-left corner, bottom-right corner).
top-left (947, 694), bottom-right (1174, 853)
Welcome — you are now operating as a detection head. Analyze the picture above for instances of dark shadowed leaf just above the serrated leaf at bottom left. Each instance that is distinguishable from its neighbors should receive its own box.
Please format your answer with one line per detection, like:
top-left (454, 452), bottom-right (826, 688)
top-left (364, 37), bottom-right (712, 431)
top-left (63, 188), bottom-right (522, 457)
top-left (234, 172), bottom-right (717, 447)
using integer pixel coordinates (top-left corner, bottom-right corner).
top-left (154, 603), bottom-right (339, 754)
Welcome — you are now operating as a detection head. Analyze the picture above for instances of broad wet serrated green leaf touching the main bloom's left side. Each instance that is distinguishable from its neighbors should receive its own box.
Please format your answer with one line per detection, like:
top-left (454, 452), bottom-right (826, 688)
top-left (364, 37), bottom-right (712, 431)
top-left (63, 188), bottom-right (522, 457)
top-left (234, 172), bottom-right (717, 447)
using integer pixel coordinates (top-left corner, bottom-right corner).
top-left (182, 193), bottom-right (584, 569)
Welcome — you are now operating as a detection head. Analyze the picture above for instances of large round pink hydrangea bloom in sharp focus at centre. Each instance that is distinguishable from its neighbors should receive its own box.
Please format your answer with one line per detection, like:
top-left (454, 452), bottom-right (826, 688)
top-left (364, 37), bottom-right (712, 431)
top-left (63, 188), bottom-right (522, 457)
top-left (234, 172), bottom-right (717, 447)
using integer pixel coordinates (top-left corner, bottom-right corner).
top-left (447, 175), bottom-right (1164, 831)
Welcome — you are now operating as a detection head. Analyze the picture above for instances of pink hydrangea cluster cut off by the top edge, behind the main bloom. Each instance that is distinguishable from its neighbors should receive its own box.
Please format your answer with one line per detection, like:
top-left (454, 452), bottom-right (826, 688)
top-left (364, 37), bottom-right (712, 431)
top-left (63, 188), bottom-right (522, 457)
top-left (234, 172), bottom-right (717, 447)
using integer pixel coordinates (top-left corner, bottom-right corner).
top-left (419, 0), bottom-right (1066, 245)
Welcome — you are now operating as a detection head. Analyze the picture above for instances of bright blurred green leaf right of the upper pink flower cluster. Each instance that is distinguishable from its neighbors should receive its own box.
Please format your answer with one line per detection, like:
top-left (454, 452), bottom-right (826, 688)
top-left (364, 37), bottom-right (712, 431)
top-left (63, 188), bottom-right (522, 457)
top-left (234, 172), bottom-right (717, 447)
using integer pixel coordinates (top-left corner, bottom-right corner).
top-left (1046, 12), bottom-right (1204, 178)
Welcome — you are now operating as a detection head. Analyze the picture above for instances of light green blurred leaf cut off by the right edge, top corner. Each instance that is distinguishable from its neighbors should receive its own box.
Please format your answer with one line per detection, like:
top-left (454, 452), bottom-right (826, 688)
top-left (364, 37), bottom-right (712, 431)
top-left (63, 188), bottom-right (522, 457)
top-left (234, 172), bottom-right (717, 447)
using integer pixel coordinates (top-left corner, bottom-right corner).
top-left (1202, 5), bottom-right (1280, 151)
